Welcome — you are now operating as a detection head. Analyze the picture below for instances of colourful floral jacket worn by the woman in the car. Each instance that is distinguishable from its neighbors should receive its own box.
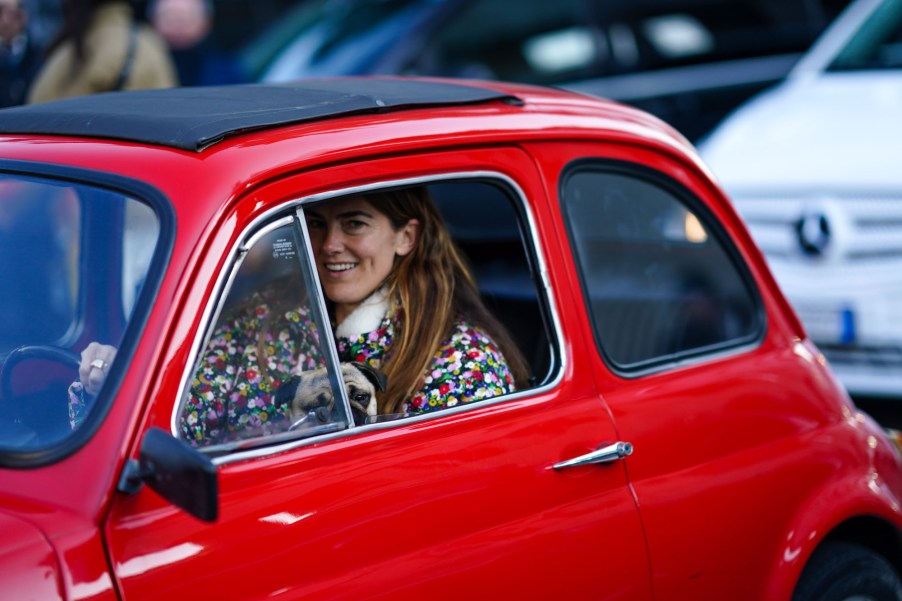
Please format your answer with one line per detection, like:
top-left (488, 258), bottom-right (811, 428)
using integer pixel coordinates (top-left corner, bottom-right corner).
top-left (70, 290), bottom-right (514, 446)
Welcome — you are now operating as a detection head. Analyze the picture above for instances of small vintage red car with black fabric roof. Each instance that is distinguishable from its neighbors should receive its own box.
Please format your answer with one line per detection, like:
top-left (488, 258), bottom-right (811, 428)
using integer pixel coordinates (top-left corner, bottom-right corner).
top-left (0, 78), bottom-right (902, 601)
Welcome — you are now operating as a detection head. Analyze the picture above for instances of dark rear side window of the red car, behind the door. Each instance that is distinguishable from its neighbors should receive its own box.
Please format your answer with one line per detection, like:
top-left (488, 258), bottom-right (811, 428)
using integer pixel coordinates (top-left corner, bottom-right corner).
top-left (561, 166), bottom-right (763, 372)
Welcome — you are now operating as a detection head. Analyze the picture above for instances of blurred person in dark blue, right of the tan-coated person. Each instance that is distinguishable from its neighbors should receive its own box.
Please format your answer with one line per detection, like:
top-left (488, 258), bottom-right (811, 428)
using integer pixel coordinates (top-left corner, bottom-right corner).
top-left (147, 0), bottom-right (249, 86)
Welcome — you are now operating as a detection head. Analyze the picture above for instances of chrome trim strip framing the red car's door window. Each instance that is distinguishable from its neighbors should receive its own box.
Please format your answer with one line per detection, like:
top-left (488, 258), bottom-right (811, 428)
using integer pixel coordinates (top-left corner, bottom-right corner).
top-left (171, 171), bottom-right (567, 465)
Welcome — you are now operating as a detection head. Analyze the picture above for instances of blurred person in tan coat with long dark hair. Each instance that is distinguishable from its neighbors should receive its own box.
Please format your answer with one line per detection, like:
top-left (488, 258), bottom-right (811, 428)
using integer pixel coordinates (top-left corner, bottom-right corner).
top-left (27, 0), bottom-right (178, 103)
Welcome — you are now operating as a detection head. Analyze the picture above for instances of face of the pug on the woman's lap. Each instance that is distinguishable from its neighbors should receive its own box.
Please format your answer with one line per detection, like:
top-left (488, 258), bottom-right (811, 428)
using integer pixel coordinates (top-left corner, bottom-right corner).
top-left (276, 362), bottom-right (386, 425)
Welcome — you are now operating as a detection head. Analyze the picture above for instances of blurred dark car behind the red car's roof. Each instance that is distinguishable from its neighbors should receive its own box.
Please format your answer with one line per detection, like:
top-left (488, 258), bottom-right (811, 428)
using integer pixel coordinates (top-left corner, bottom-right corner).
top-left (242, 0), bottom-right (846, 140)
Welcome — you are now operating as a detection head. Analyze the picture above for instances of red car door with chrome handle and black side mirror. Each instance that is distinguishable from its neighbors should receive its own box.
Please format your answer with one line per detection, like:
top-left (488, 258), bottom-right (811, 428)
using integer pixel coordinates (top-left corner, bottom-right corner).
top-left (106, 147), bottom-right (651, 600)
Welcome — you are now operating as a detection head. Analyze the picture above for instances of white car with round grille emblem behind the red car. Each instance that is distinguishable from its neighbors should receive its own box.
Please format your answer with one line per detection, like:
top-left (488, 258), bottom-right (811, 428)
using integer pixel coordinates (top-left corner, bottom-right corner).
top-left (700, 0), bottom-right (902, 404)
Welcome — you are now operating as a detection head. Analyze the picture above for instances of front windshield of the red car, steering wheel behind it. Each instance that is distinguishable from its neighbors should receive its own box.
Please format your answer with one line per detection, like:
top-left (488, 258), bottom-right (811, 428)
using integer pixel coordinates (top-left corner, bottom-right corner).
top-left (0, 174), bottom-right (160, 451)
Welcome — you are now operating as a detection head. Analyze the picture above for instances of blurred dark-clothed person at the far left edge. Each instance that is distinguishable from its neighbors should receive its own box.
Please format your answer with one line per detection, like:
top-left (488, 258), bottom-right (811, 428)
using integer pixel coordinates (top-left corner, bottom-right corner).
top-left (0, 0), bottom-right (40, 107)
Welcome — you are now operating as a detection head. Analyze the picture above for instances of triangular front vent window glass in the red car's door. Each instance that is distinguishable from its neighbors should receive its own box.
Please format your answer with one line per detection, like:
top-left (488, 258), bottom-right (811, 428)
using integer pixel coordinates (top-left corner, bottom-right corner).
top-left (177, 218), bottom-right (347, 447)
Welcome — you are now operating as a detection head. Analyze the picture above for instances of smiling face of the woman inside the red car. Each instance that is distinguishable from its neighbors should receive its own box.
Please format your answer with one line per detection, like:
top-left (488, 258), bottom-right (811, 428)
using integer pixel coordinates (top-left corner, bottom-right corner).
top-left (305, 196), bottom-right (419, 323)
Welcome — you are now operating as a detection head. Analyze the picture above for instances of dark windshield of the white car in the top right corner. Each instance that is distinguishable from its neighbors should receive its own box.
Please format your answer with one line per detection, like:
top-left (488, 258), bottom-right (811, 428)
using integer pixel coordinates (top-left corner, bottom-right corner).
top-left (827, 0), bottom-right (902, 71)
